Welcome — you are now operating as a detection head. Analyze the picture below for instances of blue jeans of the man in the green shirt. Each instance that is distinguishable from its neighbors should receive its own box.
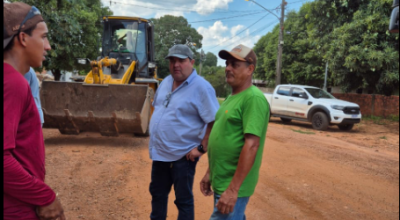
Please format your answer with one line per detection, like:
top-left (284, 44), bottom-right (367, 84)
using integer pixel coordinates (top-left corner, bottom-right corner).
top-left (210, 194), bottom-right (250, 220)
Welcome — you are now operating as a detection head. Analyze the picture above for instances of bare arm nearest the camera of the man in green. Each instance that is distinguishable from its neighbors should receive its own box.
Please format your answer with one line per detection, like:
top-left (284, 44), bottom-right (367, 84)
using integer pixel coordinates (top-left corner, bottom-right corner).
top-left (217, 134), bottom-right (260, 214)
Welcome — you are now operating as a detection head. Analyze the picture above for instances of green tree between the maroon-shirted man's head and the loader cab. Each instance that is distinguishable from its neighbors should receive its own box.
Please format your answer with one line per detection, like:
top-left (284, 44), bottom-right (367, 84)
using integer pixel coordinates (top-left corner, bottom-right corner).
top-left (11, 0), bottom-right (112, 80)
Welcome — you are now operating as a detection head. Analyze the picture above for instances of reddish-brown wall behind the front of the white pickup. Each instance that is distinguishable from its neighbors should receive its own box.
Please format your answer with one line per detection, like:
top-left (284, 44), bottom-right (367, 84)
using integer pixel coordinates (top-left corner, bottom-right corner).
top-left (333, 93), bottom-right (399, 117)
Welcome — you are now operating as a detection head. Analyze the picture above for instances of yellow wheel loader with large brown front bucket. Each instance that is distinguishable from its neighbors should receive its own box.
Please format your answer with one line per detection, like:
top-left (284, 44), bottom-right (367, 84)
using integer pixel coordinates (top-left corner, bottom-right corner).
top-left (41, 16), bottom-right (160, 136)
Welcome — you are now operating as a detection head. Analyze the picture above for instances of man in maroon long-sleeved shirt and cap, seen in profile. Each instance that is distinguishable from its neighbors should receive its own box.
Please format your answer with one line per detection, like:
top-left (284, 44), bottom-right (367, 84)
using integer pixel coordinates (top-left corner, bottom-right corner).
top-left (3, 2), bottom-right (65, 220)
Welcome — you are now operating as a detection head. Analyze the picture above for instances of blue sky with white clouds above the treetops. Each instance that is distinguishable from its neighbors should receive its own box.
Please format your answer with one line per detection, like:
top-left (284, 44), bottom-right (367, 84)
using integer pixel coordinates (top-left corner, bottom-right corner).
top-left (101, 0), bottom-right (312, 65)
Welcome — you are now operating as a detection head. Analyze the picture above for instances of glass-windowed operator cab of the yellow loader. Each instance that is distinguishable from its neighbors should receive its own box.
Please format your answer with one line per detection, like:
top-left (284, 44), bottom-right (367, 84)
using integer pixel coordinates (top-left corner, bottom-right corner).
top-left (102, 17), bottom-right (156, 82)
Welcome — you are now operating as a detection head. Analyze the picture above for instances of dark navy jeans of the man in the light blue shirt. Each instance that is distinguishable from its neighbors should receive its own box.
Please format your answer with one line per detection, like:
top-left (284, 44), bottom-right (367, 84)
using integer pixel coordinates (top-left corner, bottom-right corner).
top-left (150, 156), bottom-right (198, 220)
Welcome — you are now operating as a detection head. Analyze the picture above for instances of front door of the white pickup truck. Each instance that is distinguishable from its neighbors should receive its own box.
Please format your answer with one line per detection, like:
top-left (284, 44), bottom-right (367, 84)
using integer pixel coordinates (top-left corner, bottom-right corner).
top-left (287, 87), bottom-right (310, 118)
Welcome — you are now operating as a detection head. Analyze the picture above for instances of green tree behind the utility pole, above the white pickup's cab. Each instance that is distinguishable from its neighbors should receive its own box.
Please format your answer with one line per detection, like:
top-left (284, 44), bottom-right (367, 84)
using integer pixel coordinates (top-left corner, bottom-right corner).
top-left (254, 6), bottom-right (324, 87)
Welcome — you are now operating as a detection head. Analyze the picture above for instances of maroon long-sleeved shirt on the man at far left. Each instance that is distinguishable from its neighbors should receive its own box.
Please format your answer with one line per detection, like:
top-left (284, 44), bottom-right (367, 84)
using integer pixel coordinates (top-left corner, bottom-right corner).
top-left (3, 63), bottom-right (56, 220)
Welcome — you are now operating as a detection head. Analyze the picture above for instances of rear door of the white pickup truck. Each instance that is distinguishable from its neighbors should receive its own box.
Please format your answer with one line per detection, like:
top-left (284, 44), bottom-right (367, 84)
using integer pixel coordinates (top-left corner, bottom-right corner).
top-left (272, 86), bottom-right (291, 115)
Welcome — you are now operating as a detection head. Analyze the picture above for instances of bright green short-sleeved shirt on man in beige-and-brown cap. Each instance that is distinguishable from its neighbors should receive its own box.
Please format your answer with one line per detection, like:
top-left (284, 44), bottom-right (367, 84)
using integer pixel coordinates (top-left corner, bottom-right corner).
top-left (208, 86), bottom-right (270, 197)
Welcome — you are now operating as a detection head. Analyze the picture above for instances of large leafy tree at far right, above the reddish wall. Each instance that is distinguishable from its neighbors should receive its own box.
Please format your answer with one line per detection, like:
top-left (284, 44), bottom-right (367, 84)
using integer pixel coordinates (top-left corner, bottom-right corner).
top-left (327, 0), bottom-right (399, 95)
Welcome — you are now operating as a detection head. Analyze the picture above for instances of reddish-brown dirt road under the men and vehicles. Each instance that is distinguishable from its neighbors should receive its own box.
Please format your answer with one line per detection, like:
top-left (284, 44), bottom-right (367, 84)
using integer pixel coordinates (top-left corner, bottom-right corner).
top-left (44, 119), bottom-right (399, 220)
